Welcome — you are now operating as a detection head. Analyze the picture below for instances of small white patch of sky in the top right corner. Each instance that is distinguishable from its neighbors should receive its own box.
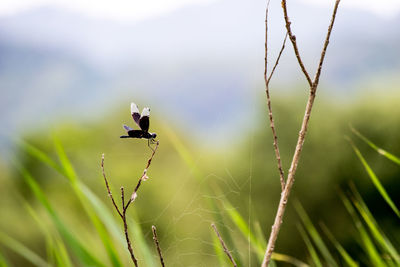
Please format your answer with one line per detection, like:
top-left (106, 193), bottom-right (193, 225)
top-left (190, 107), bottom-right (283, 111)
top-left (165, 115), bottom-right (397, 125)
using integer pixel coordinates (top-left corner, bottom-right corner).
top-left (302, 0), bottom-right (400, 18)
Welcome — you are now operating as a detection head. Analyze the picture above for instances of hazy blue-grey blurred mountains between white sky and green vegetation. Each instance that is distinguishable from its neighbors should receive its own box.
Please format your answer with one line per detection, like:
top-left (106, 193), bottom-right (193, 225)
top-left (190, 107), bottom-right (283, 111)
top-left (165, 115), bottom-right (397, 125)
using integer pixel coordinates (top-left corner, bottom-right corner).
top-left (0, 0), bottom-right (400, 153)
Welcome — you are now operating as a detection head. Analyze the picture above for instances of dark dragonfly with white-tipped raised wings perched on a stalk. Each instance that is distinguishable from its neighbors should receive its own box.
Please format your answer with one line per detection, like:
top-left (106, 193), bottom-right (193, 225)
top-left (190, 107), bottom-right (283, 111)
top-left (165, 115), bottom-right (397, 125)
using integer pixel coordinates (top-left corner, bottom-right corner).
top-left (120, 102), bottom-right (157, 148)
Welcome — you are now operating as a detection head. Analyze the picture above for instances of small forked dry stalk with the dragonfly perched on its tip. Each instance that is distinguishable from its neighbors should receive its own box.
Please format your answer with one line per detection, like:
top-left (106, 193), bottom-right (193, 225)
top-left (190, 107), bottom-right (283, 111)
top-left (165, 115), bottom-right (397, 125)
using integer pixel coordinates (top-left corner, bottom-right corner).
top-left (101, 141), bottom-right (159, 267)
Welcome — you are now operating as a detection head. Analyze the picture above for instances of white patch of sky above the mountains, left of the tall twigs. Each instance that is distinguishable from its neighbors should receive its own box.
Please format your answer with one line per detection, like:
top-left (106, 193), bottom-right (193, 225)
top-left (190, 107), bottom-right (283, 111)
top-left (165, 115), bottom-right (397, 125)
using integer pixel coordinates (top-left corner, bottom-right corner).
top-left (0, 0), bottom-right (216, 21)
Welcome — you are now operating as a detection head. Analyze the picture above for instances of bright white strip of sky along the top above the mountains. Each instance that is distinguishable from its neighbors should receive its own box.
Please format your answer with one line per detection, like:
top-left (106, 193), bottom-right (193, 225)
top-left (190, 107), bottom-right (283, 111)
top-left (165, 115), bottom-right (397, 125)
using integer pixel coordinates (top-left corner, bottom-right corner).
top-left (0, 0), bottom-right (400, 22)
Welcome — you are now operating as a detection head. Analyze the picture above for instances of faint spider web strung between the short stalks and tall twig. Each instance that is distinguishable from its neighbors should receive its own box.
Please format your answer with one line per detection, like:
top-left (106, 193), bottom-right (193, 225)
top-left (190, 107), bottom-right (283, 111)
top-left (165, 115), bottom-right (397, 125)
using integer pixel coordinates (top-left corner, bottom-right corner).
top-left (130, 134), bottom-right (255, 267)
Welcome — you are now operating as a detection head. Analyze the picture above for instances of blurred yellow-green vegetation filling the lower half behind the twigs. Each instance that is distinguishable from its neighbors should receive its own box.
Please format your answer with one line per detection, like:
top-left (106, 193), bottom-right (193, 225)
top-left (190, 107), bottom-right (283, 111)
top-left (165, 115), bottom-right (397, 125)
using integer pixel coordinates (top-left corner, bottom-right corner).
top-left (0, 89), bottom-right (400, 266)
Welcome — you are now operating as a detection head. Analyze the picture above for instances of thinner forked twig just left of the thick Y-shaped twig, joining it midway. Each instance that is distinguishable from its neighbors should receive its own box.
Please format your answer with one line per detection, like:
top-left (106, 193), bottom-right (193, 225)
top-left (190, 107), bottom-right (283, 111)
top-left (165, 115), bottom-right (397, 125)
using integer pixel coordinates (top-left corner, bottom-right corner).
top-left (264, 1), bottom-right (287, 191)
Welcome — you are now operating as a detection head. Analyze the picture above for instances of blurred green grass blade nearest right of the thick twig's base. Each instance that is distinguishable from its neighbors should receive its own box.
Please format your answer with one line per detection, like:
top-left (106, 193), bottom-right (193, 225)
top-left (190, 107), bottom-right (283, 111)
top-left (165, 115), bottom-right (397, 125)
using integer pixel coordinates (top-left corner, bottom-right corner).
top-left (294, 201), bottom-right (338, 266)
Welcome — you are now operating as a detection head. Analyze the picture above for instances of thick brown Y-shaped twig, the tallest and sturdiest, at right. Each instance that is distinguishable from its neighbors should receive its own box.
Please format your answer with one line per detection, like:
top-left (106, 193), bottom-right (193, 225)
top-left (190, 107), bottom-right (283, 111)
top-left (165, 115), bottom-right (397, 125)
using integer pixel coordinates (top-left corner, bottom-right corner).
top-left (262, 0), bottom-right (340, 267)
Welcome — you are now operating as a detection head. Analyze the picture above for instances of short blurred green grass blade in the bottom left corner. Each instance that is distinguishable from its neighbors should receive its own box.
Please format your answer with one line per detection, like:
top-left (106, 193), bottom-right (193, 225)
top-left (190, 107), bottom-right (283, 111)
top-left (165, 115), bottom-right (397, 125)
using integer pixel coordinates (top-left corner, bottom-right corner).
top-left (0, 232), bottom-right (51, 267)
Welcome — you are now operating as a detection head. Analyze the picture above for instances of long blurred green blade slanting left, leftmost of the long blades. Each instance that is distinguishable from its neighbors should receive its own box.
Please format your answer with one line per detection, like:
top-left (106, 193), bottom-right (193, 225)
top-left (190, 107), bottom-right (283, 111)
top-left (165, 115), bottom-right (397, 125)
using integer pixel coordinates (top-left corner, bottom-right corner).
top-left (17, 165), bottom-right (104, 266)
